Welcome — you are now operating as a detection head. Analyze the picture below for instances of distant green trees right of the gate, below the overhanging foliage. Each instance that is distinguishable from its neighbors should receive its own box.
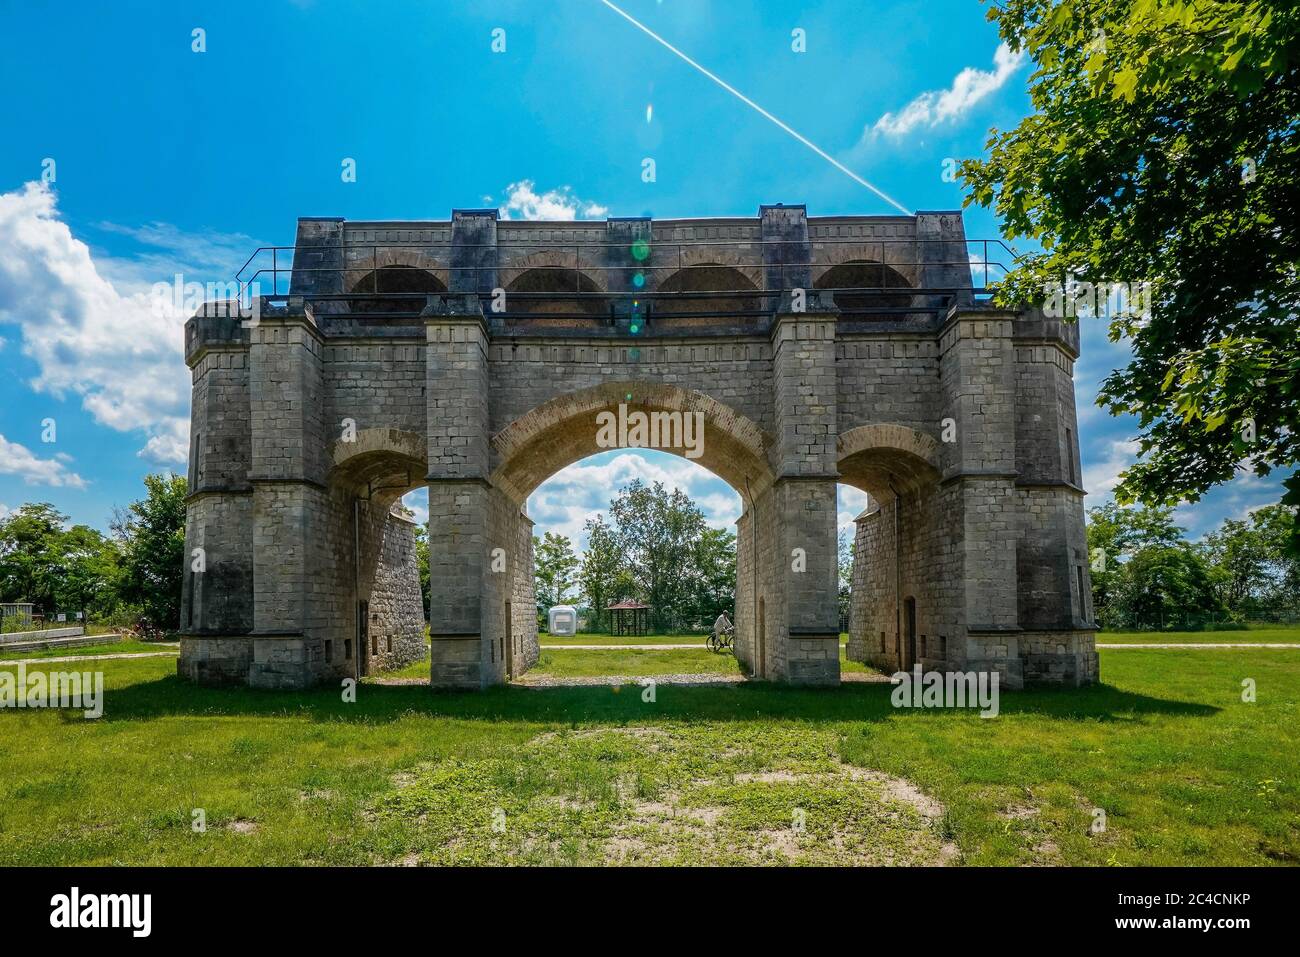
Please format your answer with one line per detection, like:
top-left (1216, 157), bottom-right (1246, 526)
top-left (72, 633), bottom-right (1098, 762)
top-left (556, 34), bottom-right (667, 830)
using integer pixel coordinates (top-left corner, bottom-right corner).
top-left (1088, 503), bottom-right (1300, 629)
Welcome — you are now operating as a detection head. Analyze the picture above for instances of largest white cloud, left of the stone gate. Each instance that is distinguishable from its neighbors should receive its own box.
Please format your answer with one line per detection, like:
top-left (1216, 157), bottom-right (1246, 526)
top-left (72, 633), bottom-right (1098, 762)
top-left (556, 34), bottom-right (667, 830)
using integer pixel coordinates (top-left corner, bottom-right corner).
top-left (0, 182), bottom-right (202, 462)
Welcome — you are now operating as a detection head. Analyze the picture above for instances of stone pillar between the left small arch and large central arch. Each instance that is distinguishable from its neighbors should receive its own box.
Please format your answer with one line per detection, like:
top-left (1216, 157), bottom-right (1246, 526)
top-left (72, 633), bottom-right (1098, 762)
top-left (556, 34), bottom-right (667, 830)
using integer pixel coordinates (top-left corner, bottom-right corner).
top-left (424, 295), bottom-right (493, 688)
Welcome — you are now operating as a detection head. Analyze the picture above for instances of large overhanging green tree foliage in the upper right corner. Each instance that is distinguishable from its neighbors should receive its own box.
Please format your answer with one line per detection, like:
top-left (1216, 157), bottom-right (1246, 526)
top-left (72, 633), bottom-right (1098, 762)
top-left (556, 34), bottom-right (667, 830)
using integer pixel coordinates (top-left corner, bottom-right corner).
top-left (962, 0), bottom-right (1300, 554)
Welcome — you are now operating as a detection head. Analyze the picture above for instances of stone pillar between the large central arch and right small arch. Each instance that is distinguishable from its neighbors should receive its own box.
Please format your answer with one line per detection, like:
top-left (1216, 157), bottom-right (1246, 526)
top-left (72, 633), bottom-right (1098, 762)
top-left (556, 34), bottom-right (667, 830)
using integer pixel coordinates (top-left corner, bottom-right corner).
top-left (755, 307), bottom-right (840, 684)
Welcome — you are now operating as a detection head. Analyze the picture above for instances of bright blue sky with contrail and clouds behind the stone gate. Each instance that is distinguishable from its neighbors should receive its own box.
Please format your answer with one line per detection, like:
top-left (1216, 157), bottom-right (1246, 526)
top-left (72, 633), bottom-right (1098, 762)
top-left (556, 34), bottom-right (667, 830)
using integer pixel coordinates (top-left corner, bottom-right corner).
top-left (0, 0), bottom-right (1279, 546)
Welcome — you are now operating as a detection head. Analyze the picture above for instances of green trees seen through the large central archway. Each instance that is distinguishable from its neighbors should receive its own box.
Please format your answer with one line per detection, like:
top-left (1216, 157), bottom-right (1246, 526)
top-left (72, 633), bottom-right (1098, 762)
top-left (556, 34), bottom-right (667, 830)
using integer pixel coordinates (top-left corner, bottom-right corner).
top-left (533, 480), bottom-right (736, 633)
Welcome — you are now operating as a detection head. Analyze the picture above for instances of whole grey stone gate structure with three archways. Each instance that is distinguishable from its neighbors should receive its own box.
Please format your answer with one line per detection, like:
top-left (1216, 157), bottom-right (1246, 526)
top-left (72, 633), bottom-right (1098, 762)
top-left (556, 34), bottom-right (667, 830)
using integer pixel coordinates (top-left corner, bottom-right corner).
top-left (178, 207), bottom-right (1097, 688)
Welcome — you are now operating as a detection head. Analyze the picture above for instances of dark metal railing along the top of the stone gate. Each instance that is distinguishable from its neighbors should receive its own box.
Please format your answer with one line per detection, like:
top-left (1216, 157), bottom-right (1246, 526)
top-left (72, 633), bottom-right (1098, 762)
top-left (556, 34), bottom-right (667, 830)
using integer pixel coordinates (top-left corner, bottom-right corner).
top-left (235, 238), bottom-right (1018, 324)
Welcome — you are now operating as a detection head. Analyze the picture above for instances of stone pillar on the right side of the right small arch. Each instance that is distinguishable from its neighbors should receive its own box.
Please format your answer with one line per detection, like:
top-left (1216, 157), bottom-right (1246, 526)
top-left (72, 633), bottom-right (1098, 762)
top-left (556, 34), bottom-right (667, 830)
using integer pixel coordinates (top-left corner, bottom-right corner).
top-left (937, 311), bottom-right (1023, 688)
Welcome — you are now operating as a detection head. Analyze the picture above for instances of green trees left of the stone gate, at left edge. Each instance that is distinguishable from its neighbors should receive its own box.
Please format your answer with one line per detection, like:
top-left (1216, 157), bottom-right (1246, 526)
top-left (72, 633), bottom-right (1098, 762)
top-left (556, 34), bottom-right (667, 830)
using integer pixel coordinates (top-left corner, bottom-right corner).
top-left (0, 475), bottom-right (186, 629)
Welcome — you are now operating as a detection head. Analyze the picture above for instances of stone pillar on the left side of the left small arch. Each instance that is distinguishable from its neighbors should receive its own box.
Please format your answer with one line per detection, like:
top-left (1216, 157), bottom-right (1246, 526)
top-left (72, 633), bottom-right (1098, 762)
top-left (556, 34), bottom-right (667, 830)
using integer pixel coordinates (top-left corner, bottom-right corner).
top-left (248, 299), bottom-right (330, 688)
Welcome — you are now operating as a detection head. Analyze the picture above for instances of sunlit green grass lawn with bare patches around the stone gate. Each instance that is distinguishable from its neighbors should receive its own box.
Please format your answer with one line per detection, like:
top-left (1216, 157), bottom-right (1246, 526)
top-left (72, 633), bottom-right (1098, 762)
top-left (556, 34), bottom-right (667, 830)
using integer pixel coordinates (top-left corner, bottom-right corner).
top-left (0, 650), bottom-right (1300, 865)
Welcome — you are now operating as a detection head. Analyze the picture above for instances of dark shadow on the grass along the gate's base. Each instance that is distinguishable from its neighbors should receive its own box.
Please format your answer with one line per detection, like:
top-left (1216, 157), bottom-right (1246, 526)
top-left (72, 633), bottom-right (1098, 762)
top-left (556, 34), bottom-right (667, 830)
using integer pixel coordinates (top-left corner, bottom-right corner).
top-left (91, 675), bottom-right (1219, 724)
